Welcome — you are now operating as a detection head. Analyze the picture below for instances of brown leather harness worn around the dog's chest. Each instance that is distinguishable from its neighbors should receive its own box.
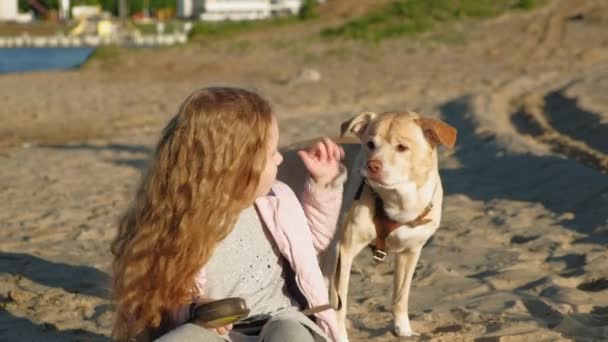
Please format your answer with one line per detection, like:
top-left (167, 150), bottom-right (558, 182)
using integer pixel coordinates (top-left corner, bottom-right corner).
top-left (355, 178), bottom-right (439, 262)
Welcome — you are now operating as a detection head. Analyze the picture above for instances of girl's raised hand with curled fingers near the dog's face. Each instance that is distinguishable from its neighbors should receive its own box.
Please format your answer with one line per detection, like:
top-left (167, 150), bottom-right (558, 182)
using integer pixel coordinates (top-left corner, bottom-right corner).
top-left (298, 138), bottom-right (344, 187)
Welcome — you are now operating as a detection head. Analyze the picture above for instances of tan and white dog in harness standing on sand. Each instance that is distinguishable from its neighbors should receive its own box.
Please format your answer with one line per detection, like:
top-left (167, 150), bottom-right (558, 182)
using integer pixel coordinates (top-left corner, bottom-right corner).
top-left (330, 112), bottom-right (456, 341)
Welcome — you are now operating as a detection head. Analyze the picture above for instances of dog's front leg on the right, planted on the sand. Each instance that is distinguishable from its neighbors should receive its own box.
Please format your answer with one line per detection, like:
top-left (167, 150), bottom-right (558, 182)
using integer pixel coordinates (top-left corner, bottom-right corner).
top-left (393, 247), bottom-right (422, 337)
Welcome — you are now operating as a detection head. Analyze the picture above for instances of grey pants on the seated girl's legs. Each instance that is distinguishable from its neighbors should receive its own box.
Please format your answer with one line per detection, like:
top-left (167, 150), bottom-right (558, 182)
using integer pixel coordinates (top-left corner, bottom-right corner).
top-left (156, 318), bottom-right (315, 342)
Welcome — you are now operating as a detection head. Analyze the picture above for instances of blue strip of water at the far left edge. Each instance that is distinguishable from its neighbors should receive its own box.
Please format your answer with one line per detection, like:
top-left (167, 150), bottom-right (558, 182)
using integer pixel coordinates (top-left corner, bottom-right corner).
top-left (0, 47), bottom-right (95, 74)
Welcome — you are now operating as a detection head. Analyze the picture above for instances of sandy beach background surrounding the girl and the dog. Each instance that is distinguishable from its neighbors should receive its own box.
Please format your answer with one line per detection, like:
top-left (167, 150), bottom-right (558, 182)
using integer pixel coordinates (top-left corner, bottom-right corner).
top-left (0, 0), bottom-right (608, 341)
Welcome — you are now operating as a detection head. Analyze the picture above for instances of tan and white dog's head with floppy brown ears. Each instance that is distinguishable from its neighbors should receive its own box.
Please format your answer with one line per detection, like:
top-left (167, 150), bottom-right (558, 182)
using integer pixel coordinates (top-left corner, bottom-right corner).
top-left (341, 112), bottom-right (456, 189)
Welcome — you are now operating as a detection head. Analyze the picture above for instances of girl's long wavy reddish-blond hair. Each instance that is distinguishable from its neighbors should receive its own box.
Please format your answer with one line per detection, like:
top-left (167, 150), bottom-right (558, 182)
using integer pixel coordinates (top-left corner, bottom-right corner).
top-left (112, 87), bottom-right (273, 340)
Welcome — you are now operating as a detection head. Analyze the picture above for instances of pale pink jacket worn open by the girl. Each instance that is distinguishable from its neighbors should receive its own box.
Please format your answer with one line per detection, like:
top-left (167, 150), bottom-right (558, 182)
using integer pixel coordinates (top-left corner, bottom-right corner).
top-left (175, 172), bottom-right (345, 341)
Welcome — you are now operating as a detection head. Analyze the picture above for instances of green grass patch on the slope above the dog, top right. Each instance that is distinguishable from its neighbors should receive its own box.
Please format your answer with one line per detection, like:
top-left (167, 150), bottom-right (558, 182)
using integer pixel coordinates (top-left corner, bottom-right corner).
top-left (321, 0), bottom-right (543, 41)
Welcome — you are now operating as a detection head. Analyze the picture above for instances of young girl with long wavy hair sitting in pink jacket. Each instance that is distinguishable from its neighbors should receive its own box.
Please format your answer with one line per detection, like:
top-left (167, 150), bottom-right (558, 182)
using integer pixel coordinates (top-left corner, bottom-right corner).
top-left (112, 87), bottom-right (345, 342)
